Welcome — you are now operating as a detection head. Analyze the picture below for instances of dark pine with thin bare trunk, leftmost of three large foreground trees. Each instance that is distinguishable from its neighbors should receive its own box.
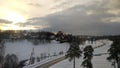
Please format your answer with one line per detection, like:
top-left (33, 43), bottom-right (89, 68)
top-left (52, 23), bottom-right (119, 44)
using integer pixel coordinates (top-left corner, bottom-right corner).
top-left (66, 37), bottom-right (82, 68)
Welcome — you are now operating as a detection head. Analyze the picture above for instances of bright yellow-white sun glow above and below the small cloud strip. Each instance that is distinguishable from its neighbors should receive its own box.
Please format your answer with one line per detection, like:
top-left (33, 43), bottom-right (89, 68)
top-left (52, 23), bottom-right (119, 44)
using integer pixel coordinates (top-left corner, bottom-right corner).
top-left (0, 9), bottom-right (34, 30)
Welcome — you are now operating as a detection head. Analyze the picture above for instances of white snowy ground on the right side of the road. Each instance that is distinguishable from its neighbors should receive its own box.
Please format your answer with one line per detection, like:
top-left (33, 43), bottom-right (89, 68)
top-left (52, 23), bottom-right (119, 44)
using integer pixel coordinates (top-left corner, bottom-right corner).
top-left (50, 40), bottom-right (114, 68)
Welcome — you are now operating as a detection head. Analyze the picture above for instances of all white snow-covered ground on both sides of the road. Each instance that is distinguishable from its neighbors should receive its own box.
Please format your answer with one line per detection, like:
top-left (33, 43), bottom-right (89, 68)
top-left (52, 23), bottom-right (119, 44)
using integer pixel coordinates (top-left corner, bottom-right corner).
top-left (5, 40), bottom-right (110, 68)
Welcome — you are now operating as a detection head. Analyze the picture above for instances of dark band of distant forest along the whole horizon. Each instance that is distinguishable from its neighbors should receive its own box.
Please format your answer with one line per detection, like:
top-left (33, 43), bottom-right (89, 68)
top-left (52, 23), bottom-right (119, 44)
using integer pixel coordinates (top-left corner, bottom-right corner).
top-left (0, 30), bottom-right (120, 43)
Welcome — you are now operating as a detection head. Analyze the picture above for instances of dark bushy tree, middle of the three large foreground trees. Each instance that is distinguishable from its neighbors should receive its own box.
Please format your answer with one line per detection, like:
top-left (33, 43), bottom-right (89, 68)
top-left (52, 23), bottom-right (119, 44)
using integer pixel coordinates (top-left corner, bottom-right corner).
top-left (82, 45), bottom-right (94, 68)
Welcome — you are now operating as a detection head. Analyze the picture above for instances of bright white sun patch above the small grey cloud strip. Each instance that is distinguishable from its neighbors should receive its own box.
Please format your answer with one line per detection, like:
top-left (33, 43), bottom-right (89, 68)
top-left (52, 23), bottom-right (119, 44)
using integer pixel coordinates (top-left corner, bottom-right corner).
top-left (6, 12), bottom-right (26, 24)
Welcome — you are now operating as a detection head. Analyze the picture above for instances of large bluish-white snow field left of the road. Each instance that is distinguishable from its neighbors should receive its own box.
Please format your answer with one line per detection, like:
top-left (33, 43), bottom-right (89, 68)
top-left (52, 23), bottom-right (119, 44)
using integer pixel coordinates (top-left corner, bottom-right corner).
top-left (5, 40), bottom-right (69, 61)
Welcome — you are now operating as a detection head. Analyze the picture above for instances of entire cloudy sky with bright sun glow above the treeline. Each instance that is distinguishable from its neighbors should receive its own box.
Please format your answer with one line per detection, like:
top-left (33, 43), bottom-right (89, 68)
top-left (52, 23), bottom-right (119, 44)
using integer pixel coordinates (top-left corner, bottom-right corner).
top-left (0, 0), bottom-right (120, 35)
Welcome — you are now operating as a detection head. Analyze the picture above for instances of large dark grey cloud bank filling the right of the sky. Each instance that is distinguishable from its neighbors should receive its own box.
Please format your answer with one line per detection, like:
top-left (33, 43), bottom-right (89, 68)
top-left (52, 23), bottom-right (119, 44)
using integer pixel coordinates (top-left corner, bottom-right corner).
top-left (30, 2), bottom-right (120, 35)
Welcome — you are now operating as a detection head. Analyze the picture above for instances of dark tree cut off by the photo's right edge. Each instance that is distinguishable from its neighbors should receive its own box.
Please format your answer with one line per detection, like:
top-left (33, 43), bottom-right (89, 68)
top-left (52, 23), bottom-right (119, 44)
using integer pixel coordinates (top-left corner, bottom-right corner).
top-left (107, 40), bottom-right (120, 68)
